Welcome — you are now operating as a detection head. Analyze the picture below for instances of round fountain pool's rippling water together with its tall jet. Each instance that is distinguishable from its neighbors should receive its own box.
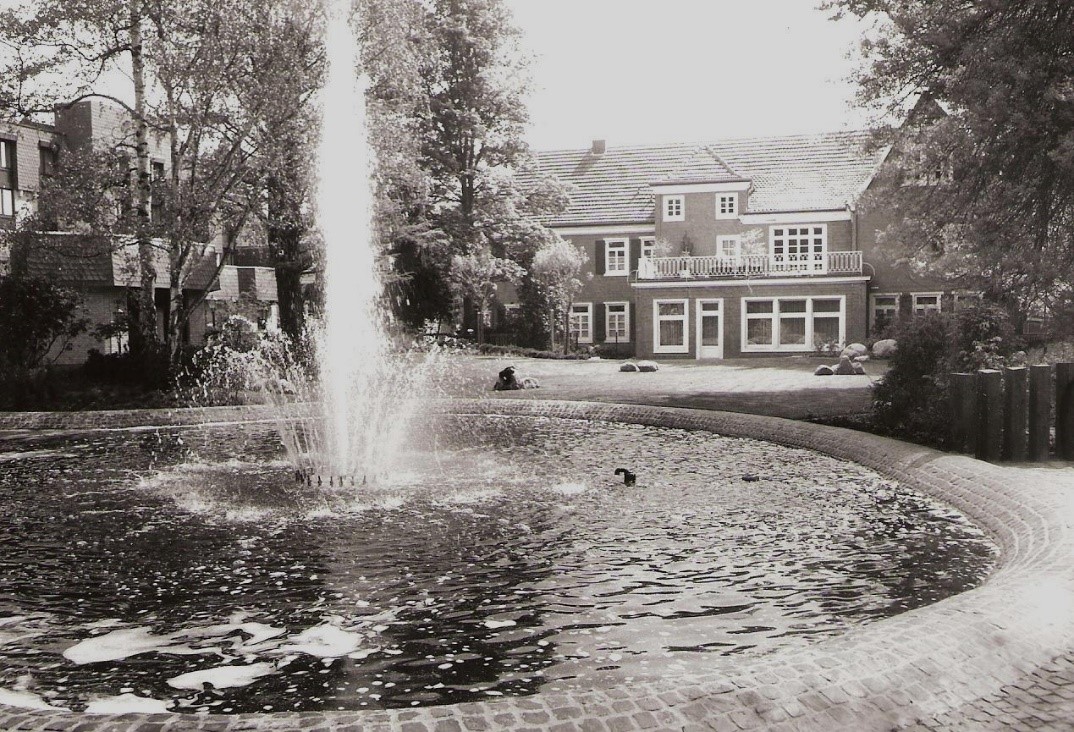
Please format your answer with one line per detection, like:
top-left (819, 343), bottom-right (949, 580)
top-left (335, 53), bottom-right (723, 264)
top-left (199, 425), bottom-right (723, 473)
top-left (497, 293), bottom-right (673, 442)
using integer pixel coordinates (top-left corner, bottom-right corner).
top-left (0, 3), bottom-right (995, 715)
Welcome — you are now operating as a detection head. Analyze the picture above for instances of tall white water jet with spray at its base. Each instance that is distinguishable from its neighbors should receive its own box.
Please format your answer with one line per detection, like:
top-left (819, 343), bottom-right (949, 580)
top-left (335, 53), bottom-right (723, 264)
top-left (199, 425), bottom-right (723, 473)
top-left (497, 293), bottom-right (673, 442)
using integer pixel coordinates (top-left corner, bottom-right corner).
top-left (259, 0), bottom-right (429, 487)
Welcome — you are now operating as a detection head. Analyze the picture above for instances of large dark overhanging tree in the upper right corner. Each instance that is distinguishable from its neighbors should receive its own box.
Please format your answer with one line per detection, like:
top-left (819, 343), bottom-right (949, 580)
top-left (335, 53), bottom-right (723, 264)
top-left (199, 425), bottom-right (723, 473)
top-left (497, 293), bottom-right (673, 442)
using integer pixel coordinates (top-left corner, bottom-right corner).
top-left (828, 0), bottom-right (1074, 324)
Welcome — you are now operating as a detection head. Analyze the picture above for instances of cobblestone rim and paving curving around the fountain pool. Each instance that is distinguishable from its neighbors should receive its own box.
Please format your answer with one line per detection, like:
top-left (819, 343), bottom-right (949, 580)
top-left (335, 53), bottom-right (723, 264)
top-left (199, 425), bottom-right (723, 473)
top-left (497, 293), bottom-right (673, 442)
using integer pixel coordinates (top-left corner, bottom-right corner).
top-left (0, 399), bottom-right (1074, 732)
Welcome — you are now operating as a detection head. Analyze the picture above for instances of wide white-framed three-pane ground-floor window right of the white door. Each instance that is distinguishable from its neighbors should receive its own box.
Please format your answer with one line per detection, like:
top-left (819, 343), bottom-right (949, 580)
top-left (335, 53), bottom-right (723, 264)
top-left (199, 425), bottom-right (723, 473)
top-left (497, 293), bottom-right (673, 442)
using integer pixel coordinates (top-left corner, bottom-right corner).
top-left (742, 296), bottom-right (846, 353)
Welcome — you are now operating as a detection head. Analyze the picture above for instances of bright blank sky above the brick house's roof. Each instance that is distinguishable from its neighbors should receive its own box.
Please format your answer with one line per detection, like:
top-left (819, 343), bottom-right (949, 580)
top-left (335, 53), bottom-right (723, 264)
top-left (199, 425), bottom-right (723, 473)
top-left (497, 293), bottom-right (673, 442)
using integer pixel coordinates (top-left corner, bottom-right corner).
top-left (505, 0), bottom-right (868, 150)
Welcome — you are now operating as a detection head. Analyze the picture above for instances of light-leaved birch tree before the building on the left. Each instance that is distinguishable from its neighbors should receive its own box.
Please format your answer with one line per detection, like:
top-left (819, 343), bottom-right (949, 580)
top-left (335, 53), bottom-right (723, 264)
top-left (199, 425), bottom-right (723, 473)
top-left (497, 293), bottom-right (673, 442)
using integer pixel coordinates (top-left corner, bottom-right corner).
top-left (0, 0), bottom-right (326, 365)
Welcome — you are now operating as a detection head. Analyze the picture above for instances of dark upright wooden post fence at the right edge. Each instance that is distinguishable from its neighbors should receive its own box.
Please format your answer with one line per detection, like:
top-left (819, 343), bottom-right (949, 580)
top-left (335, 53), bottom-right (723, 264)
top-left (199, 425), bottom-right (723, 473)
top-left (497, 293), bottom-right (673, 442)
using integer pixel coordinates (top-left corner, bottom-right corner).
top-left (950, 363), bottom-right (1074, 463)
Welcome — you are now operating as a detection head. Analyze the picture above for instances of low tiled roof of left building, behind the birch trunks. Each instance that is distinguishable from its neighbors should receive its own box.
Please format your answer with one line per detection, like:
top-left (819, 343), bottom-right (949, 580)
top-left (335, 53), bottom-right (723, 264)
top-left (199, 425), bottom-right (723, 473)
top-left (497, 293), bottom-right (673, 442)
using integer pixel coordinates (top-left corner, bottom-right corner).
top-left (12, 233), bottom-right (216, 290)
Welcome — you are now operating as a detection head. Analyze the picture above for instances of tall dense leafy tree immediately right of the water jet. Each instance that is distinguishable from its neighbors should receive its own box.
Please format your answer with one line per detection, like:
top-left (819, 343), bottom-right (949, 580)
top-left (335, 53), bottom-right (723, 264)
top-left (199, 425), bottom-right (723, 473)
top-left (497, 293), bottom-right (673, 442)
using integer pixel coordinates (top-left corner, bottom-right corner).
top-left (362, 0), bottom-right (566, 325)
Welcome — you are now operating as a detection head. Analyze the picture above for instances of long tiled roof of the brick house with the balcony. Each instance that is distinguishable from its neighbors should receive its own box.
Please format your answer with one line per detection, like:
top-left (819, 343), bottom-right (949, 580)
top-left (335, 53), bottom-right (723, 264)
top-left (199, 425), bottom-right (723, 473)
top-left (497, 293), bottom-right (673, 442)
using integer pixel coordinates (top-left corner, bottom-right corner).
top-left (536, 132), bottom-right (881, 225)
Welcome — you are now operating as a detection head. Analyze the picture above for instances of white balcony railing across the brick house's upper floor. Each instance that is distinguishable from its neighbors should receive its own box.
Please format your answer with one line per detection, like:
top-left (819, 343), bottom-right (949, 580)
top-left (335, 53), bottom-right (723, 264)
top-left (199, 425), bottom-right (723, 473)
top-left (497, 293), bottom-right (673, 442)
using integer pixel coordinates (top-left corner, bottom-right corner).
top-left (638, 251), bottom-right (861, 279)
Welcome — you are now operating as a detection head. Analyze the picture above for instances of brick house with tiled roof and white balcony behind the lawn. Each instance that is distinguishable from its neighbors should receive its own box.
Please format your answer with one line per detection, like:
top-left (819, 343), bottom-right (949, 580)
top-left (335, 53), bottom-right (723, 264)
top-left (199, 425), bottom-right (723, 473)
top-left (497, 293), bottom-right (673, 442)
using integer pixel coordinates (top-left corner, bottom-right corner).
top-left (528, 132), bottom-right (955, 360)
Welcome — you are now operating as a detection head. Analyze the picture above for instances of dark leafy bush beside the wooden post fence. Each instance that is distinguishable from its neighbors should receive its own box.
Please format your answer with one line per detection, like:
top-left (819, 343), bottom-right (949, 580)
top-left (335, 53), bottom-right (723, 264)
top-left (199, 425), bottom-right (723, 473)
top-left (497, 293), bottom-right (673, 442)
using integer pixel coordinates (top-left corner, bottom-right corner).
top-left (873, 305), bottom-right (1020, 448)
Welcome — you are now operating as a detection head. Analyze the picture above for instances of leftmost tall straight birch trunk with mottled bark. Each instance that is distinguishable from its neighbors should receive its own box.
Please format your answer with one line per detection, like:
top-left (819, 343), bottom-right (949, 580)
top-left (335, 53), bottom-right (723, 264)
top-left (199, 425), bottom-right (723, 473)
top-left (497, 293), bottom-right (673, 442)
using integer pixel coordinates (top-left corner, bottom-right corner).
top-left (130, 0), bottom-right (157, 356)
